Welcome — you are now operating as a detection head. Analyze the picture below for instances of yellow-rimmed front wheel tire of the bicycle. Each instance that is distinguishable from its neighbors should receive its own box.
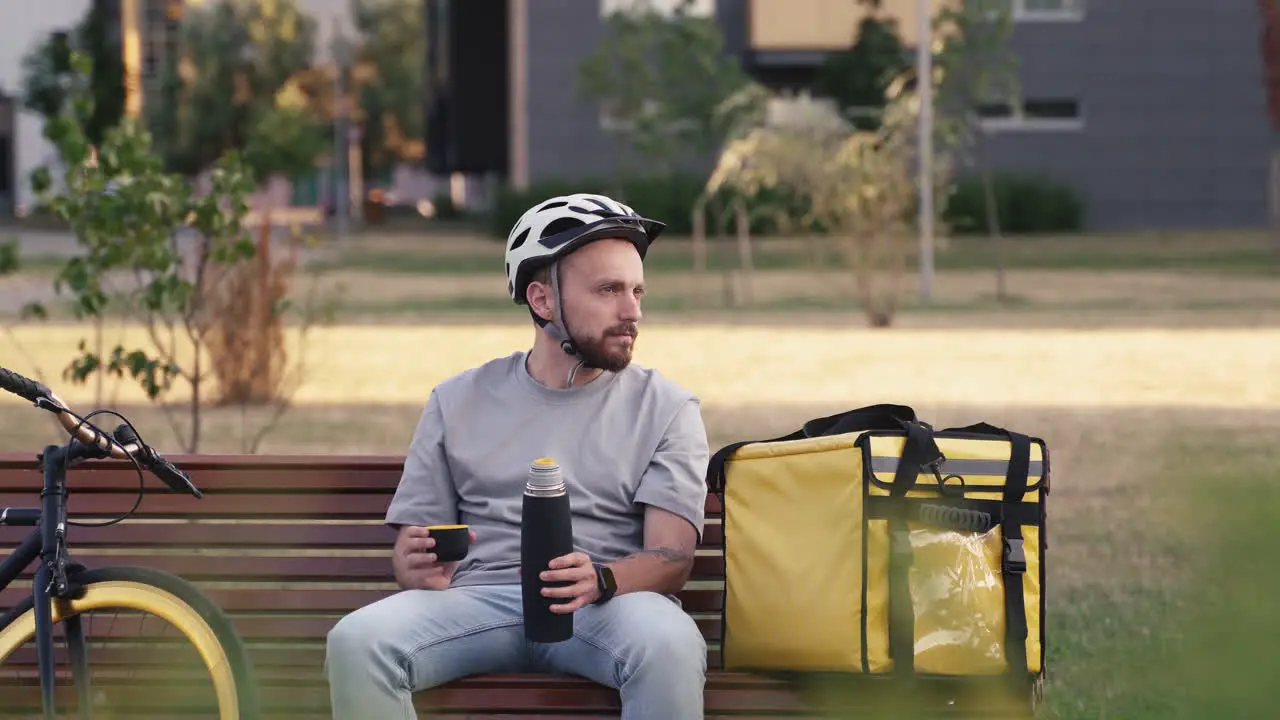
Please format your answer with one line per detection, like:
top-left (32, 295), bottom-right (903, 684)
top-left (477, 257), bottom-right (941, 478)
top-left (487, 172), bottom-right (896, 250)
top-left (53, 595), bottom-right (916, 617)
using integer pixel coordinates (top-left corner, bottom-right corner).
top-left (0, 566), bottom-right (260, 720)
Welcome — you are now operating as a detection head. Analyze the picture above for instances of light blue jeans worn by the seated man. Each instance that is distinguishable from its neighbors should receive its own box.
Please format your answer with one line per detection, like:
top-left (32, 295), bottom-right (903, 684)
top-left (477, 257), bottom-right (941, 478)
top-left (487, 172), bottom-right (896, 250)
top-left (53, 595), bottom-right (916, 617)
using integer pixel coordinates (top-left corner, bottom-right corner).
top-left (317, 584), bottom-right (707, 720)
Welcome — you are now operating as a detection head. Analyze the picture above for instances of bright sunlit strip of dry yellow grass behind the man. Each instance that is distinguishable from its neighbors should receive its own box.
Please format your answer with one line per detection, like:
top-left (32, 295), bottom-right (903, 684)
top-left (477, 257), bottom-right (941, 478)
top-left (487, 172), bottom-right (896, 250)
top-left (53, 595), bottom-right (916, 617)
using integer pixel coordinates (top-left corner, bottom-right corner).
top-left (0, 319), bottom-right (1280, 411)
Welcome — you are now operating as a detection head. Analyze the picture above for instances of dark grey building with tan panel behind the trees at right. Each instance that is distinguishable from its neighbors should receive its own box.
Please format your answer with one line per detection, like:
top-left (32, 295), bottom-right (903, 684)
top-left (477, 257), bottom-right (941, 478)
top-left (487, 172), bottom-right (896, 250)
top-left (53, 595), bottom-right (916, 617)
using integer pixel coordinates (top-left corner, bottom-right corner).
top-left (435, 0), bottom-right (1271, 231)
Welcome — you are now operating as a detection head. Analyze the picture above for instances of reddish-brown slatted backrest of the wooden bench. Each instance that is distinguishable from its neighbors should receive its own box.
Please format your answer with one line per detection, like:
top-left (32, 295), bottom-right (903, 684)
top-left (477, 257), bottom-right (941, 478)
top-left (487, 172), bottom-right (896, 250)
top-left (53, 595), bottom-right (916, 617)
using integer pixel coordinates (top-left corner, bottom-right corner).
top-left (0, 454), bottom-right (724, 667)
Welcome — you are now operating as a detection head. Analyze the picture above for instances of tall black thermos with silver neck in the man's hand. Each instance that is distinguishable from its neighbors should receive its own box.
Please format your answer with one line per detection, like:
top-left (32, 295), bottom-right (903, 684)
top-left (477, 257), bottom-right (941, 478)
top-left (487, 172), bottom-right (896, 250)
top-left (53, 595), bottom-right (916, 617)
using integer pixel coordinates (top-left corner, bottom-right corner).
top-left (520, 457), bottom-right (573, 643)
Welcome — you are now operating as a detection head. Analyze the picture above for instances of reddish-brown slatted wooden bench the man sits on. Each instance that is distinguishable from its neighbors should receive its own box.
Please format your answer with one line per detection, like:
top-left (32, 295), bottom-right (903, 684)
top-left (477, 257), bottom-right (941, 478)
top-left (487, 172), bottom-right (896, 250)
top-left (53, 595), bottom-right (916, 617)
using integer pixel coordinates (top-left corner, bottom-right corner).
top-left (0, 454), bottom-right (1028, 719)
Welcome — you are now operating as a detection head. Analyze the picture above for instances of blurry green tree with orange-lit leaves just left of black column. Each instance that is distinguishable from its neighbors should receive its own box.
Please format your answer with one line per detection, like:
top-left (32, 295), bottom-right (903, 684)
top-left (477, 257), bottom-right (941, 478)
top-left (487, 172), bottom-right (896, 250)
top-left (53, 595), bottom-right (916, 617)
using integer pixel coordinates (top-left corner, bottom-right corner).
top-left (351, 0), bottom-right (426, 179)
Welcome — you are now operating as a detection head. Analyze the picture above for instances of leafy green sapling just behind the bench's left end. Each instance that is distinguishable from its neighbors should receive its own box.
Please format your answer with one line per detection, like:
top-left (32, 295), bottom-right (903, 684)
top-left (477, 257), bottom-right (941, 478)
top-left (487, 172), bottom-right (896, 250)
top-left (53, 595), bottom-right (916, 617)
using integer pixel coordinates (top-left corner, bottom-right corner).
top-left (31, 54), bottom-right (332, 452)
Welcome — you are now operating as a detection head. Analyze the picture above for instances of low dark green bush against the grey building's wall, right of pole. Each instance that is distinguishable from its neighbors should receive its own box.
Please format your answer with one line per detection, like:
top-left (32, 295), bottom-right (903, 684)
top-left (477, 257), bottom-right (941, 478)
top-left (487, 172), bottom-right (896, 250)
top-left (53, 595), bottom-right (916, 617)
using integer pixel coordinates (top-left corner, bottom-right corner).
top-left (943, 173), bottom-right (1084, 234)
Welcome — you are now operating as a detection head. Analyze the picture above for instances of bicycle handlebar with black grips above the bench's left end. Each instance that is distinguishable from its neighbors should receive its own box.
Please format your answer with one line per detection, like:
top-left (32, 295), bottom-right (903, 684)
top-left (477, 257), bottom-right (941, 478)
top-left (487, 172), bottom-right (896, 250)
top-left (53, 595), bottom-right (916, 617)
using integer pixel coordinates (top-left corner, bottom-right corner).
top-left (0, 368), bottom-right (204, 497)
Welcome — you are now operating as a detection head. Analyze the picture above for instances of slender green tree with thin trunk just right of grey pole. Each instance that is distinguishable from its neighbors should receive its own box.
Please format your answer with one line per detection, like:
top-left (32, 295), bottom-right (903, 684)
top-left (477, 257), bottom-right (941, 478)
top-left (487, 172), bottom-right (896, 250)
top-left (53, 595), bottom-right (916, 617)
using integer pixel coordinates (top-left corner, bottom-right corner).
top-left (934, 0), bottom-right (1021, 301)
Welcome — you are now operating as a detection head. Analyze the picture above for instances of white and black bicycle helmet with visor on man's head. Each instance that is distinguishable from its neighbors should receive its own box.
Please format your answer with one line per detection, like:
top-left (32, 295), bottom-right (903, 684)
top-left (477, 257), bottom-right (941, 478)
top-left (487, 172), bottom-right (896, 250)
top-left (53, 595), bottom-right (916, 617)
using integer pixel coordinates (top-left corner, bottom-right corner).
top-left (506, 192), bottom-right (667, 360)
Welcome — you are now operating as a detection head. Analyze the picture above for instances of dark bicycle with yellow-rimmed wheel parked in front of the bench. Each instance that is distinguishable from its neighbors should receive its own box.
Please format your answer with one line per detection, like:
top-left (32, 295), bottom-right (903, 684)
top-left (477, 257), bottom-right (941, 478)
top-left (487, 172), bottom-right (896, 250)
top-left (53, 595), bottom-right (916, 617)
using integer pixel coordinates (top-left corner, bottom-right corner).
top-left (0, 368), bottom-right (260, 720)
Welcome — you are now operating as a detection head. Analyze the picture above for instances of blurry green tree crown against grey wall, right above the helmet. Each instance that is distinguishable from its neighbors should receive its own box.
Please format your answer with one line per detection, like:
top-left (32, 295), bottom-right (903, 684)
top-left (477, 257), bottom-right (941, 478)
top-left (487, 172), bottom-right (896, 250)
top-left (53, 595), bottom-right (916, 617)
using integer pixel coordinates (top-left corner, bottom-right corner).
top-left (579, 0), bottom-right (751, 174)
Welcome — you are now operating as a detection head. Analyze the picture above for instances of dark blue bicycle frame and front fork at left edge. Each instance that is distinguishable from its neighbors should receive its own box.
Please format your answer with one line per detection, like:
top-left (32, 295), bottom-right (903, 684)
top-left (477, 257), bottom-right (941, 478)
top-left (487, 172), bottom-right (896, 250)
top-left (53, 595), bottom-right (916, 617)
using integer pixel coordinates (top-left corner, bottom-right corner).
top-left (0, 441), bottom-right (106, 719)
